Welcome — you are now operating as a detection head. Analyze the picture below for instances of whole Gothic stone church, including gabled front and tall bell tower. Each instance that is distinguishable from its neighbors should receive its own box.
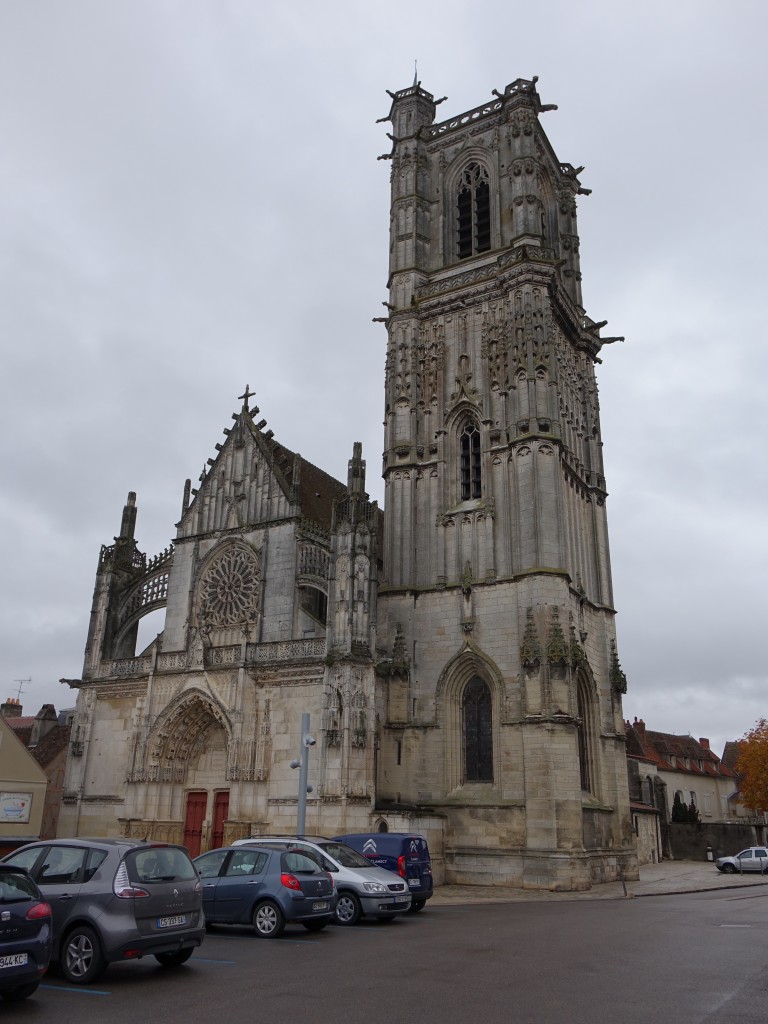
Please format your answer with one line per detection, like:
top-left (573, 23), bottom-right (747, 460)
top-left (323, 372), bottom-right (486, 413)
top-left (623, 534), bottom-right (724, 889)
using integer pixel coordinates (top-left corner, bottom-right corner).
top-left (59, 80), bottom-right (637, 890)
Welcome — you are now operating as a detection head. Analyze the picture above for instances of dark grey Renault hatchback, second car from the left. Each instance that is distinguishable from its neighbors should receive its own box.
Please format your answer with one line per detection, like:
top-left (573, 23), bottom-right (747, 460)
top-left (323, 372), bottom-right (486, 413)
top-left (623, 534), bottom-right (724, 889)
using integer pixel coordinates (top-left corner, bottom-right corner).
top-left (2, 839), bottom-right (205, 984)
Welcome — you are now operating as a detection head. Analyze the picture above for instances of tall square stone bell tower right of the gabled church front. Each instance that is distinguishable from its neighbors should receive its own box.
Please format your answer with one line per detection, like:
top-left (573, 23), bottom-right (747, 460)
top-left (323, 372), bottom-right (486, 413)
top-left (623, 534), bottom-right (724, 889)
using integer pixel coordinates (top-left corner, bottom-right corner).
top-left (377, 79), bottom-right (636, 889)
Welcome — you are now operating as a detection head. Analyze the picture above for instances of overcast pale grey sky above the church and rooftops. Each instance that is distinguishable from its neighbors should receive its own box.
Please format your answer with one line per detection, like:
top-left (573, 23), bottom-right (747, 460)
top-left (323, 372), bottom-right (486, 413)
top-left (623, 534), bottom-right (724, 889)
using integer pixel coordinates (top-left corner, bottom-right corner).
top-left (0, 0), bottom-right (768, 753)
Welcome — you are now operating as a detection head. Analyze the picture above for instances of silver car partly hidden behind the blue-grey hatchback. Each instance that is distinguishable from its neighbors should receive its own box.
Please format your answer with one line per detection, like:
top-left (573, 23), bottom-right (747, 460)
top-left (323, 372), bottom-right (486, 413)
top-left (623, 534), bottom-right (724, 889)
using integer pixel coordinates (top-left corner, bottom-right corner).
top-left (232, 836), bottom-right (411, 925)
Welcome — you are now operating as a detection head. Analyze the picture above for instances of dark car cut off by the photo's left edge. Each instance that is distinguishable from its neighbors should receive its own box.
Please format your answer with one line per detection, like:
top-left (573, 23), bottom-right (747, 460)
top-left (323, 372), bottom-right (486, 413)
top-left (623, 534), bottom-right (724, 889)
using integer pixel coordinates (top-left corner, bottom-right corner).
top-left (0, 864), bottom-right (51, 1002)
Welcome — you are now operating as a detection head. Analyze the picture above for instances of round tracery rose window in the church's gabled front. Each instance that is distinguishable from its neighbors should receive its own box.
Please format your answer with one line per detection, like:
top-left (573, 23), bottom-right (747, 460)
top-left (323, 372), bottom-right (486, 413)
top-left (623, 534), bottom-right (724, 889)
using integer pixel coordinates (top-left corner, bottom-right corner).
top-left (200, 545), bottom-right (261, 626)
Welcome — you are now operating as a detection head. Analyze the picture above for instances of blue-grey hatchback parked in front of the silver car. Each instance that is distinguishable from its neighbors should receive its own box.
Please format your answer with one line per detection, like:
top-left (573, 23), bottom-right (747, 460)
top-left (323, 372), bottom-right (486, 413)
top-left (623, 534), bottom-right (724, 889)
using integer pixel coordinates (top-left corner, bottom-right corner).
top-left (195, 846), bottom-right (336, 939)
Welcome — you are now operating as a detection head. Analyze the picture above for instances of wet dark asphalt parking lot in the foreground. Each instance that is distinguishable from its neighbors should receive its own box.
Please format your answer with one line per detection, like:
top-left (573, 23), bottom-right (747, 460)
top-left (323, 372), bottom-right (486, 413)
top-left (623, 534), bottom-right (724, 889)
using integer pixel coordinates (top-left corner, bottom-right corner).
top-left (25, 884), bottom-right (768, 1024)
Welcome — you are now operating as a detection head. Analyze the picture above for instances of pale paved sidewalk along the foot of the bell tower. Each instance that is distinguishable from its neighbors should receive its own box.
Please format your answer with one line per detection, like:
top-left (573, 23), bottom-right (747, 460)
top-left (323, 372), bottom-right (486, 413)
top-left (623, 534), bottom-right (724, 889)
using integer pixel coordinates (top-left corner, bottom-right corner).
top-left (429, 860), bottom-right (768, 906)
